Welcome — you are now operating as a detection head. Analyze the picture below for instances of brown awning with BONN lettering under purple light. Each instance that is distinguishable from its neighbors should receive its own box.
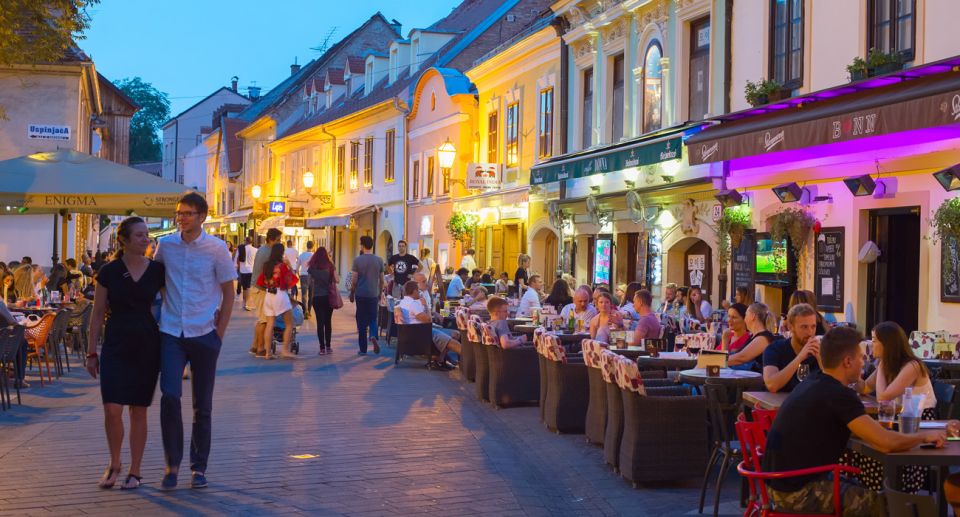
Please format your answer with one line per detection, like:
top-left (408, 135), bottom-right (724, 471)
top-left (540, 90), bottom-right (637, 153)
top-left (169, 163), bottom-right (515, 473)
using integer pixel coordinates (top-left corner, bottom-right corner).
top-left (686, 71), bottom-right (960, 165)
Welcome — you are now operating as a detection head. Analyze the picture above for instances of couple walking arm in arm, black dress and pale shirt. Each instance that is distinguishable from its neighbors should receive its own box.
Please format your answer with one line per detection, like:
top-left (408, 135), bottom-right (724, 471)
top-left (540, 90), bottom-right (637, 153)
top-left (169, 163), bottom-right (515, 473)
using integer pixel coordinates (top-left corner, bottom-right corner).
top-left (86, 192), bottom-right (237, 489)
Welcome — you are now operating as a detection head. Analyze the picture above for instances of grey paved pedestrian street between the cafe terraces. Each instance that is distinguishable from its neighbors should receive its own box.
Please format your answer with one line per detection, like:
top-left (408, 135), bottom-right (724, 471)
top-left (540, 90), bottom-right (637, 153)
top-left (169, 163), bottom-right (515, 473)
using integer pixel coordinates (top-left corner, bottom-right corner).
top-left (0, 304), bottom-right (742, 515)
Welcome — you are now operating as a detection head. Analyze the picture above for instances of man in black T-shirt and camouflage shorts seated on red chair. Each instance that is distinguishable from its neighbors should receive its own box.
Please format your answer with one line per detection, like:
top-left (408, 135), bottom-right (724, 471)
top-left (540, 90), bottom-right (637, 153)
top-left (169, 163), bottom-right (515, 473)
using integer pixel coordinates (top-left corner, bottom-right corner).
top-left (763, 326), bottom-right (946, 515)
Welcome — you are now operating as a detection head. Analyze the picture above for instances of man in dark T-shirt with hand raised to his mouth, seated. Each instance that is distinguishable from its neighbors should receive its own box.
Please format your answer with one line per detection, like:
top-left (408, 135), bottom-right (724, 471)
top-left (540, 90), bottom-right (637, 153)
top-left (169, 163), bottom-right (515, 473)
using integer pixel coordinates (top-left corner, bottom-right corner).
top-left (763, 303), bottom-right (820, 393)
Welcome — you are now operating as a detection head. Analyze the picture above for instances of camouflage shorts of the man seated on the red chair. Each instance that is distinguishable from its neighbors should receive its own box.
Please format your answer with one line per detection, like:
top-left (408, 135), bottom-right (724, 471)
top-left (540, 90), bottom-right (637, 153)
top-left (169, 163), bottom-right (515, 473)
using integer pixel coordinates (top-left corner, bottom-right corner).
top-left (767, 479), bottom-right (887, 516)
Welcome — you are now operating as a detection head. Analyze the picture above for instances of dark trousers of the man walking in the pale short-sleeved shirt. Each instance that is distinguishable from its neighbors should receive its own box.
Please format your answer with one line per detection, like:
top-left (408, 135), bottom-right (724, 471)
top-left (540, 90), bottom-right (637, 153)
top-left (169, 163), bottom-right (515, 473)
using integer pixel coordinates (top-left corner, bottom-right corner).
top-left (160, 330), bottom-right (221, 472)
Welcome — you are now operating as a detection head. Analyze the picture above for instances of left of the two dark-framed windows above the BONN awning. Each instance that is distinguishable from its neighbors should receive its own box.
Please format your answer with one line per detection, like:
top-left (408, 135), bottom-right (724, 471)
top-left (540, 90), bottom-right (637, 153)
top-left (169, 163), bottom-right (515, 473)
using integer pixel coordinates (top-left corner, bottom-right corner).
top-left (770, 0), bottom-right (803, 89)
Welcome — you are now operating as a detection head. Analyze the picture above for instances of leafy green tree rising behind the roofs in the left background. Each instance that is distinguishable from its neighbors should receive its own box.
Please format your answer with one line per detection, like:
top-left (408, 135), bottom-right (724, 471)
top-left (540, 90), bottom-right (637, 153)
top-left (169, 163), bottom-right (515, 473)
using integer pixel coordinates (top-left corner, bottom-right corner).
top-left (114, 77), bottom-right (170, 163)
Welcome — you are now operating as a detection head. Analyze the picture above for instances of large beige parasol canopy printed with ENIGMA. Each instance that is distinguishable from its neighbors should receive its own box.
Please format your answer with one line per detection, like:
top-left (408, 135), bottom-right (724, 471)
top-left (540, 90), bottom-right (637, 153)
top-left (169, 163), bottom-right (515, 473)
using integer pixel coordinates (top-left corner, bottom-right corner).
top-left (0, 149), bottom-right (187, 217)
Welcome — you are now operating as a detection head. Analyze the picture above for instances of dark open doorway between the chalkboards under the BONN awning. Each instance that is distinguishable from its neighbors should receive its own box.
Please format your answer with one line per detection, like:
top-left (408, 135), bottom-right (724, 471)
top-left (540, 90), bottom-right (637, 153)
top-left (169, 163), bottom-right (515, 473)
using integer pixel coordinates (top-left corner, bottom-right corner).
top-left (867, 206), bottom-right (921, 335)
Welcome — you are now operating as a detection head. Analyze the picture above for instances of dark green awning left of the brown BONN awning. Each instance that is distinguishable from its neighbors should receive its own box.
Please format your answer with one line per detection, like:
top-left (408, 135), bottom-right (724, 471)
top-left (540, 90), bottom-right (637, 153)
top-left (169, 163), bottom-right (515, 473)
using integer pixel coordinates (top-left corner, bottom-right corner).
top-left (530, 122), bottom-right (702, 185)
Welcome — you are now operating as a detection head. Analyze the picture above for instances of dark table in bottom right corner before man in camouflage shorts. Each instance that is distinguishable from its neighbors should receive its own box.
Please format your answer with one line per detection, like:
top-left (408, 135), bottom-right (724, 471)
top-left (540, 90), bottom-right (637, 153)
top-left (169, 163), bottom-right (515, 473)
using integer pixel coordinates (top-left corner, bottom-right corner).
top-left (849, 420), bottom-right (960, 517)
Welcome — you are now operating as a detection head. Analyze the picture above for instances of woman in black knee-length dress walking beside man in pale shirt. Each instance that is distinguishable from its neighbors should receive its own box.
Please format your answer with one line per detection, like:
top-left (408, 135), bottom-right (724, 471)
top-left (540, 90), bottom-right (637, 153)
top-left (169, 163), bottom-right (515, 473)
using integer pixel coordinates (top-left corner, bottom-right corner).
top-left (86, 217), bottom-right (164, 489)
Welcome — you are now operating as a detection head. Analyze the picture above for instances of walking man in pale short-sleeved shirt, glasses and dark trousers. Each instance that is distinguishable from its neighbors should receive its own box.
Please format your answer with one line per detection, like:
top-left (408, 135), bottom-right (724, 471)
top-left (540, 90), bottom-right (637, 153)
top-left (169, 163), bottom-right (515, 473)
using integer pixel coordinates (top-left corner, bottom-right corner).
top-left (154, 192), bottom-right (237, 490)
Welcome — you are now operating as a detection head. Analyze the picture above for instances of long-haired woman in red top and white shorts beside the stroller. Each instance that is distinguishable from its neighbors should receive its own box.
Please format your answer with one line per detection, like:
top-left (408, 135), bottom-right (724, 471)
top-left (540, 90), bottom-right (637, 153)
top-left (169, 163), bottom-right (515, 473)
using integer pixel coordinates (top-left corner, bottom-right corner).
top-left (257, 243), bottom-right (299, 359)
